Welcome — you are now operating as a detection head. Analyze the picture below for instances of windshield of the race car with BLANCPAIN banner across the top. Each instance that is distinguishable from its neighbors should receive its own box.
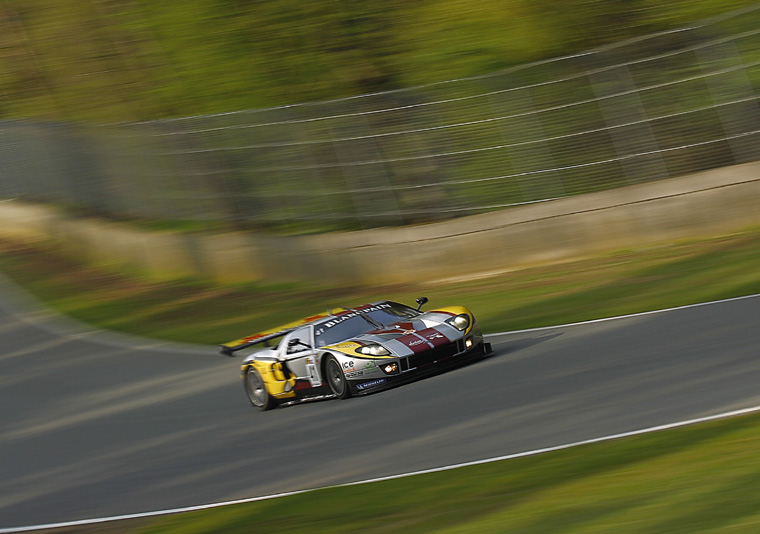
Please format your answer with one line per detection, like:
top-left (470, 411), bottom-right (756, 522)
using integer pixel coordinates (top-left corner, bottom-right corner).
top-left (314, 302), bottom-right (420, 347)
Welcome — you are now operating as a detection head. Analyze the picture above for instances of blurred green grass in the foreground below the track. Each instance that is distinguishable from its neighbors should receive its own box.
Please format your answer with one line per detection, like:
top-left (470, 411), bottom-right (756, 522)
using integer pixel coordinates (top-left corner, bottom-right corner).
top-left (139, 415), bottom-right (760, 534)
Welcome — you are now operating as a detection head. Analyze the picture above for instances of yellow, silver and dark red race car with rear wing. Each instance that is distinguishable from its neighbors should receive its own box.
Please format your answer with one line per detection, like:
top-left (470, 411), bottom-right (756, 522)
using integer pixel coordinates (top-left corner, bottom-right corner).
top-left (220, 297), bottom-right (491, 410)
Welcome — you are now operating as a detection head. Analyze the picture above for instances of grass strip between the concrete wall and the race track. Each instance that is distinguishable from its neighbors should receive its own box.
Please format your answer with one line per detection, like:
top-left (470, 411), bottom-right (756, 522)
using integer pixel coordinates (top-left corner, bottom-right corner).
top-left (0, 228), bottom-right (760, 344)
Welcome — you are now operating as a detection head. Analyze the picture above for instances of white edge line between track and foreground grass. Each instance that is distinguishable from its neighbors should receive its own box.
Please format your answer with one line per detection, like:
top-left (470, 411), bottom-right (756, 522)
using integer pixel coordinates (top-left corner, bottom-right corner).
top-left (0, 406), bottom-right (760, 534)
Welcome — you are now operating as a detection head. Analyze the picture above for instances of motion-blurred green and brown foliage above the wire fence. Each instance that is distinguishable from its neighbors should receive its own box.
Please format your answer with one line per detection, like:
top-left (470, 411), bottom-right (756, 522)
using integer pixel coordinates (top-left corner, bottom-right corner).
top-left (0, 0), bottom-right (751, 121)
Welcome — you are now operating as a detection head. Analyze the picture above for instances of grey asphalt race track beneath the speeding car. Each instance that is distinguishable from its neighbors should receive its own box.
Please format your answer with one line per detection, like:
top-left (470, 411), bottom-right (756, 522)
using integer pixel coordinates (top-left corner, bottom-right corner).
top-left (0, 284), bottom-right (760, 529)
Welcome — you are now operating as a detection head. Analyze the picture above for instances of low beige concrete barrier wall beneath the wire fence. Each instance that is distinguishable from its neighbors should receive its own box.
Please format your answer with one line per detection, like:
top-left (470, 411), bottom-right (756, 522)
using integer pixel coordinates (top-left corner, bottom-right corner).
top-left (0, 162), bottom-right (760, 286)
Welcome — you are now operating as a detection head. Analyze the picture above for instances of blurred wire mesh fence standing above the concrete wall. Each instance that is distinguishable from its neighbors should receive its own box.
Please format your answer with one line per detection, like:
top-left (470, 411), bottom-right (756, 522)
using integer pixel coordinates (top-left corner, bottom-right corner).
top-left (0, 5), bottom-right (760, 232)
